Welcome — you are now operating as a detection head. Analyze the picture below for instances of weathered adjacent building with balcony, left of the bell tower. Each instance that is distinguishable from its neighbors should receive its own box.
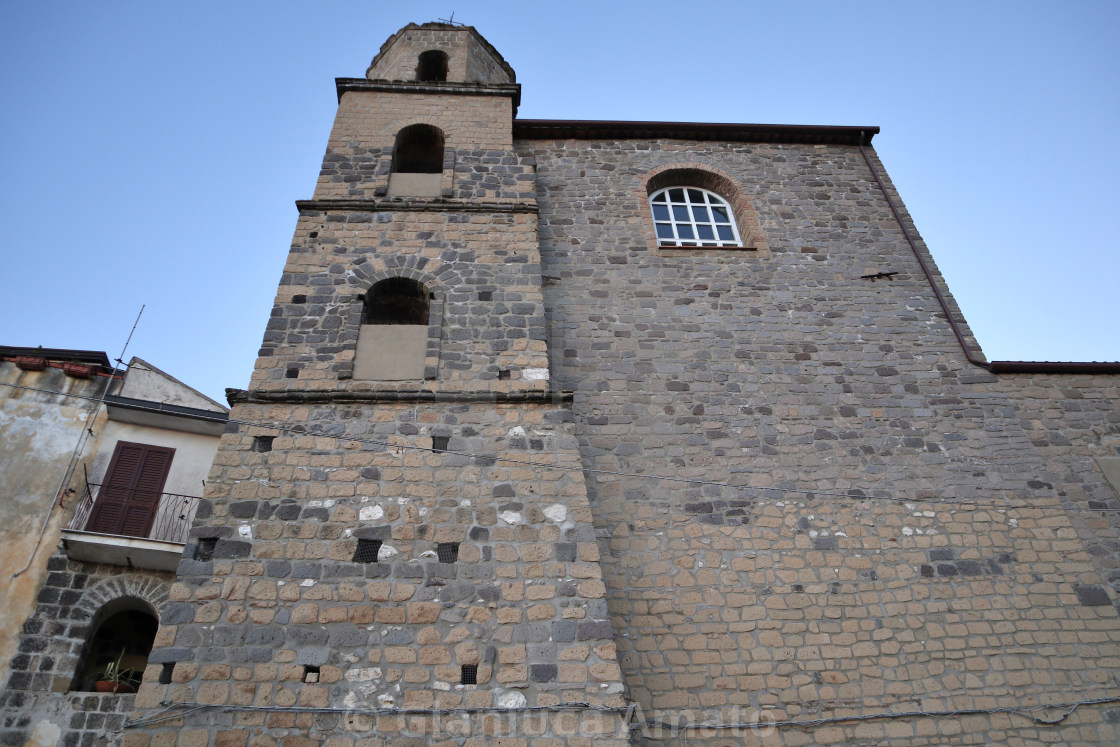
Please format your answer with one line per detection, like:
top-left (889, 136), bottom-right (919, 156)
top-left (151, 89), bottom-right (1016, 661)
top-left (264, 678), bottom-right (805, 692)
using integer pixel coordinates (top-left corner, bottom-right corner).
top-left (0, 347), bottom-right (228, 745)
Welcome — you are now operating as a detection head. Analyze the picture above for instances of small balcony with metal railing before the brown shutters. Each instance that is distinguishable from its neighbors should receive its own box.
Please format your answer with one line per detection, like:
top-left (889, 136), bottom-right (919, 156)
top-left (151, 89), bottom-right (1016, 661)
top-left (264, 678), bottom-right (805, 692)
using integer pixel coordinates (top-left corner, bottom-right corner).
top-left (63, 485), bottom-right (202, 571)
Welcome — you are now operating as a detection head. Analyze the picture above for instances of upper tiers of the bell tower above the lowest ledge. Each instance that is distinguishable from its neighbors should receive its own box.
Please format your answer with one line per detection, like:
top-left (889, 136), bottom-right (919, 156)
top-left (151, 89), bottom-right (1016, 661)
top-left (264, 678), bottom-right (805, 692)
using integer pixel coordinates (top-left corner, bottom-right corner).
top-left (275, 24), bottom-right (549, 393)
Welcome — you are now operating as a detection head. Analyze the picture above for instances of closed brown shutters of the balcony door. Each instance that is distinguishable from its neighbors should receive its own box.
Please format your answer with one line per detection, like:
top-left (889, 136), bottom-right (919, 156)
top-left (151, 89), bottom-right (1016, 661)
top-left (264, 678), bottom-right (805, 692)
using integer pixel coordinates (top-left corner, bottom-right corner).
top-left (85, 441), bottom-right (175, 536)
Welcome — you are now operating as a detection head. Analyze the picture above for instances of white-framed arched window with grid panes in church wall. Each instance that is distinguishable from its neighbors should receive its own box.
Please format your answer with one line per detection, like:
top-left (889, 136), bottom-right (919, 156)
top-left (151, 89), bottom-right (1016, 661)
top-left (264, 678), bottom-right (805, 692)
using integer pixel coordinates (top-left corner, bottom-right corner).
top-left (650, 187), bottom-right (743, 246)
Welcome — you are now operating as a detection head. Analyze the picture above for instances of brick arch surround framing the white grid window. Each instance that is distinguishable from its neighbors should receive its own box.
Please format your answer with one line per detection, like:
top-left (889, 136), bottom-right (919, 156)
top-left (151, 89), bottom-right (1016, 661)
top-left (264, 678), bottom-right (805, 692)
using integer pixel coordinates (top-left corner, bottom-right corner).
top-left (636, 161), bottom-right (769, 256)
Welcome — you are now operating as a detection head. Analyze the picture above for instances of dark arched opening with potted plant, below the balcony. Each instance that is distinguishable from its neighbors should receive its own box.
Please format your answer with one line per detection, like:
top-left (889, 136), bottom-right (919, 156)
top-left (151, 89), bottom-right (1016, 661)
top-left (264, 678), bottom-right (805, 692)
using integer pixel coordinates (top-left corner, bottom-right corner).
top-left (73, 597), bottom-right (159, 692)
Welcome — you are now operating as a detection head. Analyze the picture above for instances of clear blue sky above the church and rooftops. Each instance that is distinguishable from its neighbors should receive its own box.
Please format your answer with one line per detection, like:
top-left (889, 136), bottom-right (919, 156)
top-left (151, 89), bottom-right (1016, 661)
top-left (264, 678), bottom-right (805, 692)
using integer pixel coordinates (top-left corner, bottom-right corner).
top-left (0, 0), bottom-right (1120, 405)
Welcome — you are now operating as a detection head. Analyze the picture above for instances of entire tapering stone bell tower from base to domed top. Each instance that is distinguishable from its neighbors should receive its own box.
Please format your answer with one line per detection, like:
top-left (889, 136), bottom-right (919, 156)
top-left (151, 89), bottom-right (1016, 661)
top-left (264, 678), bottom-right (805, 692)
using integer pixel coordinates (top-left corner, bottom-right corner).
top-left (129, 24), bottom-right (626, 745)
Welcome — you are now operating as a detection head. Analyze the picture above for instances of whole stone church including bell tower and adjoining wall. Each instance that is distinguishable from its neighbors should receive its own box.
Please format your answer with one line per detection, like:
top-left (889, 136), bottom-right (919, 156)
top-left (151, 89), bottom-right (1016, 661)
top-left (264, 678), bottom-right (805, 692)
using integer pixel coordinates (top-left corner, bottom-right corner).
top-left (6, 24), bottom-right (1120, 747)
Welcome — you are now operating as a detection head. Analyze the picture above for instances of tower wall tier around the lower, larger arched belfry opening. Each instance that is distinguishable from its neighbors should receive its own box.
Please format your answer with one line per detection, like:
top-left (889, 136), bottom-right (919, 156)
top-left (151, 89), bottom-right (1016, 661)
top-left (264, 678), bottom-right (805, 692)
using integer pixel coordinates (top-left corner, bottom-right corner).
top-left (252, 202), bottom-right (548, 392)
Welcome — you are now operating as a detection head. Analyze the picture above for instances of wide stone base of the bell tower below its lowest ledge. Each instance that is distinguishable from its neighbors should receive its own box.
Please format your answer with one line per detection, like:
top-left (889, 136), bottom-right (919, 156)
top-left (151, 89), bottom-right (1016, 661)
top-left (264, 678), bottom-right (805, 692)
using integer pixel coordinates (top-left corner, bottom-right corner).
top-left (127, 398), bottom-right (623, 744)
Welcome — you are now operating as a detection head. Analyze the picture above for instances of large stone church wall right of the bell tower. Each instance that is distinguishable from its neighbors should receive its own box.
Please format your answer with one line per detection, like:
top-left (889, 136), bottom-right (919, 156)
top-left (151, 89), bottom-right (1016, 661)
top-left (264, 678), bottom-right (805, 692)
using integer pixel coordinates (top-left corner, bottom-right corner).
top-left (516, 141), bottom-right (1120, 744)
